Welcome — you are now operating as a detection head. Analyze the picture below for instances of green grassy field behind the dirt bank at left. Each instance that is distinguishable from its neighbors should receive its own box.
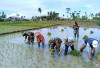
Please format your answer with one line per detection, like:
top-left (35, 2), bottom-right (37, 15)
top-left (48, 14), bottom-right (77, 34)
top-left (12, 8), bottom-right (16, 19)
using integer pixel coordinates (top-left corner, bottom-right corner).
top-left (0, 21), bottom-right (61, 33)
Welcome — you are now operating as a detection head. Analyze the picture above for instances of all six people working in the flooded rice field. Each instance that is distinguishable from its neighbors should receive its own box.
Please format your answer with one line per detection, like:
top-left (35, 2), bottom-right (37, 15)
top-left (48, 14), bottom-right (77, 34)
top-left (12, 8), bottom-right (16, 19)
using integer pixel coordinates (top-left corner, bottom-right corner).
top-left (23, 22), bottom-right (98, 59)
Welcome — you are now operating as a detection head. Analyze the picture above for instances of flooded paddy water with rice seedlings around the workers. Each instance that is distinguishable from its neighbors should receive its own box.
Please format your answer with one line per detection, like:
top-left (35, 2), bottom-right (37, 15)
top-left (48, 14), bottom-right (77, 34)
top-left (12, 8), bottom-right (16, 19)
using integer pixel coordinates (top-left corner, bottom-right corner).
top-left (0, 26), bottom-right (100, 68)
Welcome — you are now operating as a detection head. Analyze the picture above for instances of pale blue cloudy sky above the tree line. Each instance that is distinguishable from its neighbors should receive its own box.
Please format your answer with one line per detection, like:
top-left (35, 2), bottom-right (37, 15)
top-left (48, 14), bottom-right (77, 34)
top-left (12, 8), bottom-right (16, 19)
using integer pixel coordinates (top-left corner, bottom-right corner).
top-left (0, 0), bottom-right (100, 19)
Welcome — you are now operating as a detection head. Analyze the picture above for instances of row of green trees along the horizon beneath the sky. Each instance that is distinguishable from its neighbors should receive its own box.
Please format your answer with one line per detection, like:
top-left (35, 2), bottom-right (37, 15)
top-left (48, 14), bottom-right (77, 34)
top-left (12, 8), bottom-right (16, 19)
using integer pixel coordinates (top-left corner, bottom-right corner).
top-left (0, 8), bottom-right (100, 21)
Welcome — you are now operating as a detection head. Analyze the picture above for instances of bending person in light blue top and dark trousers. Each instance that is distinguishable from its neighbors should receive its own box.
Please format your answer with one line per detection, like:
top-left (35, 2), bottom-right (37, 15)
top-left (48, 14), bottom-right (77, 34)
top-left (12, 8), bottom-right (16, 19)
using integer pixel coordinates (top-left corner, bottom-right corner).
top-left (59, 37), bottom-right (75, 55)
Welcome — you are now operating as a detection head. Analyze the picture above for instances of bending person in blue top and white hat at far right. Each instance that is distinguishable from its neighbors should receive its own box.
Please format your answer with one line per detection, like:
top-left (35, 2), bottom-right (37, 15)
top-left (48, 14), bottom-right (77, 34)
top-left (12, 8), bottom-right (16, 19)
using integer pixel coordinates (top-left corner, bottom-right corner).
top-left (80, 38), bottom-right (98, 60)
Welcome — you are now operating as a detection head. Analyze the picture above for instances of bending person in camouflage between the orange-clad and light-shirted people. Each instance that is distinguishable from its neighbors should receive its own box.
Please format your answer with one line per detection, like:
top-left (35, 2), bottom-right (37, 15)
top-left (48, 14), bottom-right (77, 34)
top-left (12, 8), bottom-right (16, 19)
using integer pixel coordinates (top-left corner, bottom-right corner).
top-left (48, 37), bottom-right (62, 53)
